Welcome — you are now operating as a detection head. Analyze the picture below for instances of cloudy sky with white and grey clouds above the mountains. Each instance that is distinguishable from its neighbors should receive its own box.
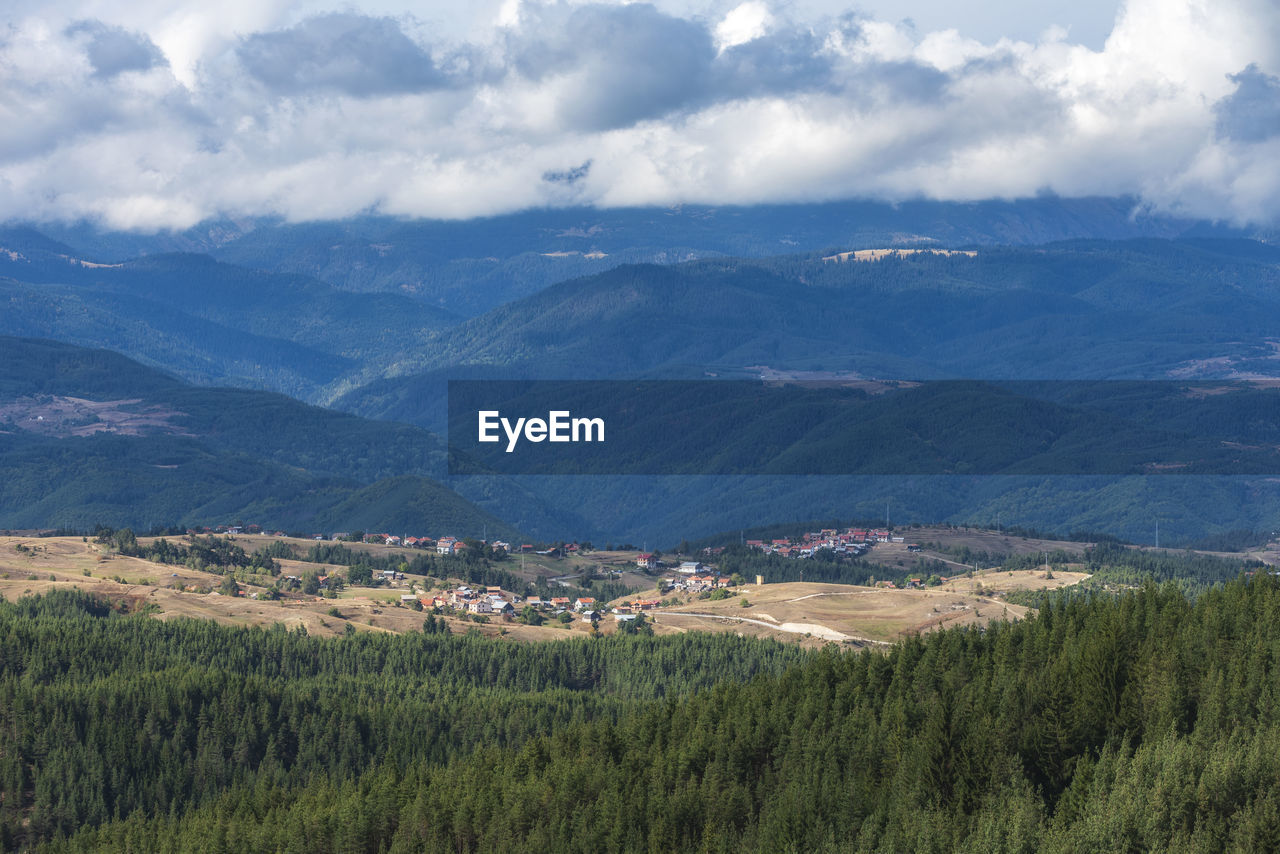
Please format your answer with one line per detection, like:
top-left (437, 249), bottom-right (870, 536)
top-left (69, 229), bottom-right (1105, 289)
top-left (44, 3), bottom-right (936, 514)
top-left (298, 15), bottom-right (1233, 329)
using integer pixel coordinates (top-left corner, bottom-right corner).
top-left (0, 0), bottom-right (1280, 230)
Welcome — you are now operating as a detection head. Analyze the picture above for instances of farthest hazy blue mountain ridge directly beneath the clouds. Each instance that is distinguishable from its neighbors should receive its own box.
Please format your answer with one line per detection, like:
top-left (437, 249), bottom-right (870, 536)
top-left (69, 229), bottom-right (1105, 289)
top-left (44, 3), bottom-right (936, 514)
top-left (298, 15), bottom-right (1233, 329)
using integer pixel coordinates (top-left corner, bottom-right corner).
top-left (15, 197), bottom-right (1223, 316)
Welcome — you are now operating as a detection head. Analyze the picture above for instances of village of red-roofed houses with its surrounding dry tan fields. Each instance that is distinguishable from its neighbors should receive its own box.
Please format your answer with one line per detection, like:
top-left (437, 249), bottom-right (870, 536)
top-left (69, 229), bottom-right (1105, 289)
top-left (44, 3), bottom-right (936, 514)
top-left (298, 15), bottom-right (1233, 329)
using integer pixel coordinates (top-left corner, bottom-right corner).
top-left (0, 525), bottom-right (1100, 645)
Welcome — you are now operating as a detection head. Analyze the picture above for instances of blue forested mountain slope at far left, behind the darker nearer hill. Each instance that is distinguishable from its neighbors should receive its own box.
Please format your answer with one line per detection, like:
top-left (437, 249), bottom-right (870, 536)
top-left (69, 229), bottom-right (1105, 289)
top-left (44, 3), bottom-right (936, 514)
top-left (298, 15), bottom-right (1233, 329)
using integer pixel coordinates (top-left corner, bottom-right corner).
top-left (0, 239), bottom-right (458, 399)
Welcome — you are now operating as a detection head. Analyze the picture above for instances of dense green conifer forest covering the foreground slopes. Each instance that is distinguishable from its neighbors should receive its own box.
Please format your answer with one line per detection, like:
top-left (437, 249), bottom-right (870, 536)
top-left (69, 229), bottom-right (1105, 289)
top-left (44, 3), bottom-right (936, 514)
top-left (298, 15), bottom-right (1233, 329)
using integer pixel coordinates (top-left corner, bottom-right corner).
top-left (10, 563), bottom-right (1280, 851)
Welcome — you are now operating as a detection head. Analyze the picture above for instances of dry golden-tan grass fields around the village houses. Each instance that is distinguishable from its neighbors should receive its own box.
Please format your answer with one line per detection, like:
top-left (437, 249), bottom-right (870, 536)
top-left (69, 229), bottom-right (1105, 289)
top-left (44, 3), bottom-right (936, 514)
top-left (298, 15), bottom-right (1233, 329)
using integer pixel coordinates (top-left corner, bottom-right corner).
top-left (0, 535), bottom-right (1087, 645)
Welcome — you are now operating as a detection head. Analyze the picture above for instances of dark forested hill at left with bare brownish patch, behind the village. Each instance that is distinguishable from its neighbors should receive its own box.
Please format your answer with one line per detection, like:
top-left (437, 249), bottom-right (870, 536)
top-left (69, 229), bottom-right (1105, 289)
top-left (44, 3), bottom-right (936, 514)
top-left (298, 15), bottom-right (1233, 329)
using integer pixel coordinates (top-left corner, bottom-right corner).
top-left (0, 338), bottom-right (538, 536)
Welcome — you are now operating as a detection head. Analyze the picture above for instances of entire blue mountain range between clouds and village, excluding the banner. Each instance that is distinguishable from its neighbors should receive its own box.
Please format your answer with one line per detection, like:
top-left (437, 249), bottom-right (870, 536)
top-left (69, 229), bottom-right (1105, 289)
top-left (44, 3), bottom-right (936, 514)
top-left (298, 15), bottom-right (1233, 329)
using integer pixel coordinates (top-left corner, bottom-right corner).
top-left (0, 198), bottom-right (1280, 540)
